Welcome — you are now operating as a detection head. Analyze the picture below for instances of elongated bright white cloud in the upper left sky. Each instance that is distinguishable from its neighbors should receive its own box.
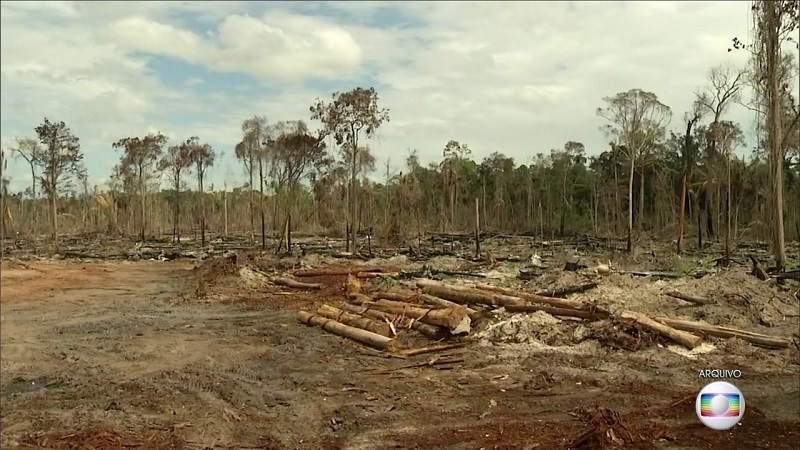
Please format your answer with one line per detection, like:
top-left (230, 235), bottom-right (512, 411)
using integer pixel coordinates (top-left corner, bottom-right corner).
top-left (105, 12), bottom-right (362, 81)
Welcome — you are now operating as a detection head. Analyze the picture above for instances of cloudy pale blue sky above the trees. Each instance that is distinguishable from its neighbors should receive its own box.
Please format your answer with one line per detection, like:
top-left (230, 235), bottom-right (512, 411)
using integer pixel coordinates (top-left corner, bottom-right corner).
top-left (0, 1), bottom-right (788, 195)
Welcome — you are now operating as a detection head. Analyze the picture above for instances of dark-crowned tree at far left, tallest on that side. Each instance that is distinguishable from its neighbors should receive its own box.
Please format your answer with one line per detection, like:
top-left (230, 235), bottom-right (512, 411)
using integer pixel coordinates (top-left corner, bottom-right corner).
top-left (35, 117), bottom-right (83, 249)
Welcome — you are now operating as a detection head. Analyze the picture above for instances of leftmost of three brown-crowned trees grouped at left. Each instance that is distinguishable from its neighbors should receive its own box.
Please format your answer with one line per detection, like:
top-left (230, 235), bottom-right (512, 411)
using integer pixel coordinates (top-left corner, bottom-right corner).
top-left (112, 133), bottom-right (167, 242)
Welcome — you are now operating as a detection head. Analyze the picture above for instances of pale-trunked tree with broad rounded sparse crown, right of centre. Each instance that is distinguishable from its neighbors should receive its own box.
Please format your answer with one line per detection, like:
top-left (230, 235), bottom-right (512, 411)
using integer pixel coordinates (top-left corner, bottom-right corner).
top-left (597, 89), bottom-right (672, 252)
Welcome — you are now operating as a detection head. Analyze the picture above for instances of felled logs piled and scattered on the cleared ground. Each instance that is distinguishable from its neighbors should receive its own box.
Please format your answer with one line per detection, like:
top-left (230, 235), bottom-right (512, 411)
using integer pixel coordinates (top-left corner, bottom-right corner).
top-left (286, 268), bottom-right (791, 356)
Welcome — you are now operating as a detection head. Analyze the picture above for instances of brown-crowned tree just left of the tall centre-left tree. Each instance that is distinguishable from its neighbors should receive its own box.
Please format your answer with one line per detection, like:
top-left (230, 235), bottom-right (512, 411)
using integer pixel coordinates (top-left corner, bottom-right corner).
top-left (268, 120), bottom-right (327, 251)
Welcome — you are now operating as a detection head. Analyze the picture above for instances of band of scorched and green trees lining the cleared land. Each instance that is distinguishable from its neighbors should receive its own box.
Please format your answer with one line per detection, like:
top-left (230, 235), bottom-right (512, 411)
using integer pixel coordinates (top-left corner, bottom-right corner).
top-left (0, 1), bottom-right (800, 268)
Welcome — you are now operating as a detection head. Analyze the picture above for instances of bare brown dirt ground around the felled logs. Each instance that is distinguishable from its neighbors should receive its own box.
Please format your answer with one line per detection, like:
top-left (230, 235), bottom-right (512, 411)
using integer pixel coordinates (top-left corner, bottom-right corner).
top-left (0, 251), bottom-right (800, 449)
